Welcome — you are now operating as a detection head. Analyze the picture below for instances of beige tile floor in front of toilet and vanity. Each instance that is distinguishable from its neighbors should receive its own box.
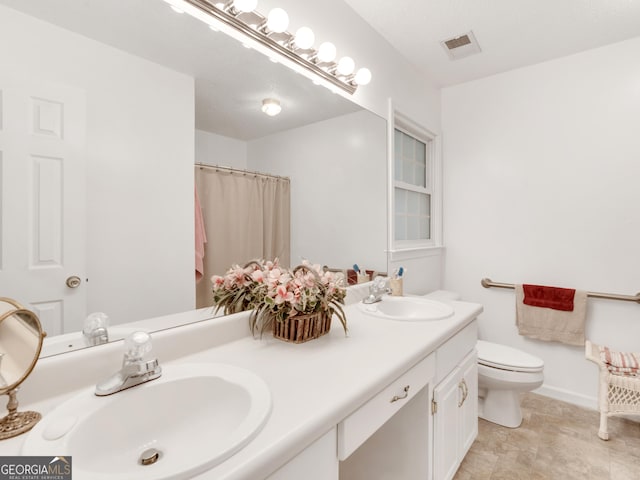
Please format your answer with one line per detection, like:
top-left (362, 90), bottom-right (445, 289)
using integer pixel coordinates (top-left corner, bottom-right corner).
top-left (454, 393), bottom-right (640, 480)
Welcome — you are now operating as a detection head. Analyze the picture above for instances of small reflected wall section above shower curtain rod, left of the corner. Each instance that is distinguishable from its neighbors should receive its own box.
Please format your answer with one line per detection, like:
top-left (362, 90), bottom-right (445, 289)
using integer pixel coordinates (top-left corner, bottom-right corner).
top-left (195, 130), bottom-right (247, 169)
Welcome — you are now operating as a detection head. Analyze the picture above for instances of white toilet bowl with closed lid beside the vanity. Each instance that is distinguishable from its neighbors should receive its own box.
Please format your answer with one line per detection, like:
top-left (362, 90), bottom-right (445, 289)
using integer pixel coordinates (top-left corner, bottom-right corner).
top-left (477, 340), bottom-right (544, 428)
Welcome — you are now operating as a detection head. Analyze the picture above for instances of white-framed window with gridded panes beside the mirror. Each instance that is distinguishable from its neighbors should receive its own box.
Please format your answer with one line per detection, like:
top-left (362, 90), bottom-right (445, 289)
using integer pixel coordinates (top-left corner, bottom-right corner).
top-left (393, 123), bottom-right (435, 249)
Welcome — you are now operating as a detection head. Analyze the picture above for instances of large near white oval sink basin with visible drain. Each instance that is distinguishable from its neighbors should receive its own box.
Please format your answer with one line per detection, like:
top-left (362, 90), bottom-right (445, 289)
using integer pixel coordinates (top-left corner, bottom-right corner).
top-left (22, 363), bottom-right (271, 480)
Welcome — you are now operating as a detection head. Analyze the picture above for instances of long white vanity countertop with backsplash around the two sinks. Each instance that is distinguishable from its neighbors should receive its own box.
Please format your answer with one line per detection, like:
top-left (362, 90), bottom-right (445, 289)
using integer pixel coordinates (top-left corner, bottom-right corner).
top-left (0, 302), bottom-right (482, 480)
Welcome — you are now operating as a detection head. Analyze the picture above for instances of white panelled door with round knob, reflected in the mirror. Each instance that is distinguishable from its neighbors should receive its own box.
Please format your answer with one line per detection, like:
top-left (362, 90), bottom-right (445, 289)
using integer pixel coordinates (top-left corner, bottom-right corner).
top-left (0, 76), bottom-right (86, 335)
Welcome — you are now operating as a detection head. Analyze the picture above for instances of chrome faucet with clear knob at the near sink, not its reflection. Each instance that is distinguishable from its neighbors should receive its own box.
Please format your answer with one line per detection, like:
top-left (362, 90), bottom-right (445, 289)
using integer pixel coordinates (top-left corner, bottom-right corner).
top-left (95, 332), bottom-right (162, 397)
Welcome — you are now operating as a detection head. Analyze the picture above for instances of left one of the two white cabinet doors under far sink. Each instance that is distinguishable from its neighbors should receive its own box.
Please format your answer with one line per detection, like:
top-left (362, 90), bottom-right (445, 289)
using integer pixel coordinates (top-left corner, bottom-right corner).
top-left (433, 368), bottom-right (462, 480)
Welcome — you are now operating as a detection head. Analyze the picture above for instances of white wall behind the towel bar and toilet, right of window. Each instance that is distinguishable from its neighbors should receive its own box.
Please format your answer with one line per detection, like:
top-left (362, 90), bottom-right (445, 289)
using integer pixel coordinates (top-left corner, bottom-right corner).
top-left (443, 38), bottom-right (640, 406)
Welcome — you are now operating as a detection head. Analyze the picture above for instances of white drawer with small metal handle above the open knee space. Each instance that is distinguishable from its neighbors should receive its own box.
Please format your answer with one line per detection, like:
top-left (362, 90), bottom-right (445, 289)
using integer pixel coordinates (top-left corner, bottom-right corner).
top-left (338, 354), bottom-right (436, 460)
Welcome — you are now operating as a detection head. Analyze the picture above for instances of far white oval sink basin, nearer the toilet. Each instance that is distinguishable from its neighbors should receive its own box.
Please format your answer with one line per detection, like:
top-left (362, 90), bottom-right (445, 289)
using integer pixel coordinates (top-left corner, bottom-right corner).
top-left (358, 296), bottom-right (454, 322)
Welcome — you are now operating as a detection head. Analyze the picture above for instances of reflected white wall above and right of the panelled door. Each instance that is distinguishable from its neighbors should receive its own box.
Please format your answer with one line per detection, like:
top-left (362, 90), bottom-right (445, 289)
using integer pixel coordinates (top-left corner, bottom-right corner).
top-left (0, 7), bottom-right (195, 323)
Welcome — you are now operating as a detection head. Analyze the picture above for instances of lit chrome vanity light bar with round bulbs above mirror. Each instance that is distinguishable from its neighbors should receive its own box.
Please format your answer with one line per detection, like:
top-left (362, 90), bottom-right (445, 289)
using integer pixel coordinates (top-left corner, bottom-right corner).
top-left (164, 0), bottom-right (371, 94)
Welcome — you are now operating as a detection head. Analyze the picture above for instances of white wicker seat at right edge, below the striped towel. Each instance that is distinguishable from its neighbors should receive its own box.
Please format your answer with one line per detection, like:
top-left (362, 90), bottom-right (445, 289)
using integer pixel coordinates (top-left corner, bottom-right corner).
top-left (585, 340), bottom-right (640, 440)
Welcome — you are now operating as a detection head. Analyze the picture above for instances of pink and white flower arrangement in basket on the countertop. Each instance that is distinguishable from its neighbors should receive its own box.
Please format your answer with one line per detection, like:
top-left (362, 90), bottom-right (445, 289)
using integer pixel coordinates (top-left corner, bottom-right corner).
top-left (211, 260), bottom-right (347, 342)
